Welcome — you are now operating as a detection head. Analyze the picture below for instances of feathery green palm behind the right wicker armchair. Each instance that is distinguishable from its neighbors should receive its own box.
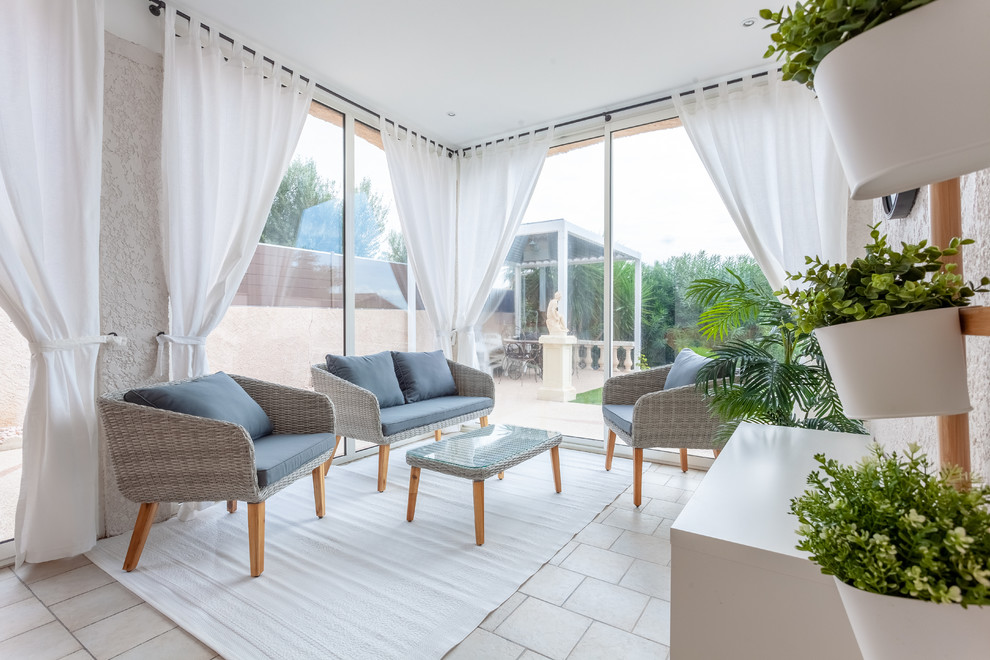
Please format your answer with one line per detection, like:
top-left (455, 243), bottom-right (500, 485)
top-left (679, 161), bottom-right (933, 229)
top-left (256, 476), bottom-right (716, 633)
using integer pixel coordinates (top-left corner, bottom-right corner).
top-left (687, 269), bottom-right (866, 443)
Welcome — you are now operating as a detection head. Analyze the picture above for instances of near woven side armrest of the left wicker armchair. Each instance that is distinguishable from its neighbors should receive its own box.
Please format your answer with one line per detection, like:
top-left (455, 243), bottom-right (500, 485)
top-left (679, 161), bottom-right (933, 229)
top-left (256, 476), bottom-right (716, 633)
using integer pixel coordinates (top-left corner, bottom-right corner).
top-left (97, 392), bottom-right (259, 502)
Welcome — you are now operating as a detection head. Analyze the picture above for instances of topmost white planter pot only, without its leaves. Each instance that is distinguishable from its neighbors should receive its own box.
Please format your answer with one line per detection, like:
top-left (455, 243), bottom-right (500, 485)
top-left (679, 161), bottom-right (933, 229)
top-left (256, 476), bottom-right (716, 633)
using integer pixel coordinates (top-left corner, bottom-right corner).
top-left (815, 0), bottom-right (990, 199)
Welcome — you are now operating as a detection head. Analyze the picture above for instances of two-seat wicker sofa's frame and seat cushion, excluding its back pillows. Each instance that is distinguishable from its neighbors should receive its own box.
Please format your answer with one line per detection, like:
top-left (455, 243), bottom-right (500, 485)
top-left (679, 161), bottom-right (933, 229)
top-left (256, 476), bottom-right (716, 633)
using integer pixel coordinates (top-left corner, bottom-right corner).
top-left (311, 360), bottom-right (495, 492)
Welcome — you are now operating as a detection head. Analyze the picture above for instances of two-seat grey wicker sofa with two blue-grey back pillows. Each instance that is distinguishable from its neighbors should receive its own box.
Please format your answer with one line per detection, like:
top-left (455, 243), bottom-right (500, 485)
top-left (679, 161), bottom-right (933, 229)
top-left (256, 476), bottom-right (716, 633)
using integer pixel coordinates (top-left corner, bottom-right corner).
top-left (311, 351), bottom-right (495, 492)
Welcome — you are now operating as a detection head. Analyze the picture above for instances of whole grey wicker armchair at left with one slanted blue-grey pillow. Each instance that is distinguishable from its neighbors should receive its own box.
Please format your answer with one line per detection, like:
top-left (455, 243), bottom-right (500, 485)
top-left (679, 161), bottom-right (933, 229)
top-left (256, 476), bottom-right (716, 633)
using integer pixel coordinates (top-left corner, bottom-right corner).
top-left (98, 372), bottom-right (337, 577)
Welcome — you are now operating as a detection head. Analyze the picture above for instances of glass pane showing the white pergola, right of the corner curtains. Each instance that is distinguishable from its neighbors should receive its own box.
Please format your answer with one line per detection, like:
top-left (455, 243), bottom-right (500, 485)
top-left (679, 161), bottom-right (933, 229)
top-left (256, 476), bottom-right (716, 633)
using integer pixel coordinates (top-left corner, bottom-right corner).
top-left (484, 138), bottom-right (606, 440)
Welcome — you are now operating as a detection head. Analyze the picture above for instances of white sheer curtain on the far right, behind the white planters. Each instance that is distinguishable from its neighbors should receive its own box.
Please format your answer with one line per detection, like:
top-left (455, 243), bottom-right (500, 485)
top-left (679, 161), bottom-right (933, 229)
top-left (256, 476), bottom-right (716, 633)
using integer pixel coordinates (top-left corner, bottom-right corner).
top-left (674, 71), bottom-right (849, 288)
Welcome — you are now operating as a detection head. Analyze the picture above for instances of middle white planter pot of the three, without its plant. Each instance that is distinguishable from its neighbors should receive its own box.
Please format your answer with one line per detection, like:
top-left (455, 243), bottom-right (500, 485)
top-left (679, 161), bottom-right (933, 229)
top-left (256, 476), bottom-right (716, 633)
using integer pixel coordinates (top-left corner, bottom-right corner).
top-left (815, 307), bottom-right (973, 419)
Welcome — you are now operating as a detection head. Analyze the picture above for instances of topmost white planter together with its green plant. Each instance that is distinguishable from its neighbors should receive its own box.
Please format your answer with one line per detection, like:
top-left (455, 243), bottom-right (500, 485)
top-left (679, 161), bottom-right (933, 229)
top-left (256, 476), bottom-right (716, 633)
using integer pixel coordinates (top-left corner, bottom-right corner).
top-left (760, 0), bottom-right (990, 199)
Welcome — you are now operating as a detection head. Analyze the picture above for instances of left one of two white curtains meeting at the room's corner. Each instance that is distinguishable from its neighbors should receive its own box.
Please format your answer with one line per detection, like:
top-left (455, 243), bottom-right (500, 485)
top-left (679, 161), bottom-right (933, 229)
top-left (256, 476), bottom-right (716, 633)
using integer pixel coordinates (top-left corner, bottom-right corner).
top-left (381, 117), bottom-right (457, 356)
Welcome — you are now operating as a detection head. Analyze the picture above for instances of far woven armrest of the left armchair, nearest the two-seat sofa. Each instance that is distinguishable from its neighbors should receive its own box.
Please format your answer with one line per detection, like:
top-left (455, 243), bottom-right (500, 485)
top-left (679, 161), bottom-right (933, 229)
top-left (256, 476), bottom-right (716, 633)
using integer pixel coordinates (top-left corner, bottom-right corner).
top-left (231, 375), bottom-right (334, 433)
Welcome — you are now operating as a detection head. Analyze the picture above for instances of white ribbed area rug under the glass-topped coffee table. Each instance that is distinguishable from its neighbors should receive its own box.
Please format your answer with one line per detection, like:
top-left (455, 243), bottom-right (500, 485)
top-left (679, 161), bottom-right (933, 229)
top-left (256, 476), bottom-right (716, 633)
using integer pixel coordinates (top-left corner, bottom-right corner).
top-left (88, 438), bottom-right (630, 660)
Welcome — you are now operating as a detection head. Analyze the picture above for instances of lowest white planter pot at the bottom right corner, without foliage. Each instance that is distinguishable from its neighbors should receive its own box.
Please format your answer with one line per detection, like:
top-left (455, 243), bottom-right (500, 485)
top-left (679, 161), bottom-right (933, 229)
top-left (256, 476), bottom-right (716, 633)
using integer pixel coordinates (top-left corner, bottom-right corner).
top-left (835, 579), bottom-right (990, 660)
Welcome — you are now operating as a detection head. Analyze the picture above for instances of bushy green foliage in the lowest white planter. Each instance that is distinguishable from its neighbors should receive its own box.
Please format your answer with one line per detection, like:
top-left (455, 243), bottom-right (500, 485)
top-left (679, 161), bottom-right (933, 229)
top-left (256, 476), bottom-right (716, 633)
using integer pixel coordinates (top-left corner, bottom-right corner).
top-left (790, 445), bottom-right (990, 605)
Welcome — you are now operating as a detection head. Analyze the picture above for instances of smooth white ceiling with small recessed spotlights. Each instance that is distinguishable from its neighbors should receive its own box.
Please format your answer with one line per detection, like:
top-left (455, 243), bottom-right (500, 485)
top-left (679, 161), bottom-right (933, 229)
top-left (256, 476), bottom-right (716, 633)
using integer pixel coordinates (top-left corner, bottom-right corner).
top-left (106, 0), bottom-right (769, 146)
